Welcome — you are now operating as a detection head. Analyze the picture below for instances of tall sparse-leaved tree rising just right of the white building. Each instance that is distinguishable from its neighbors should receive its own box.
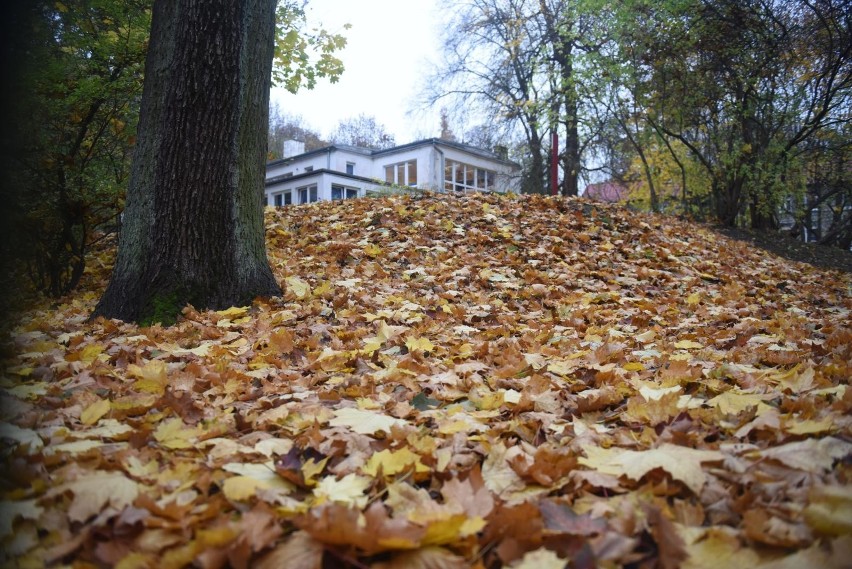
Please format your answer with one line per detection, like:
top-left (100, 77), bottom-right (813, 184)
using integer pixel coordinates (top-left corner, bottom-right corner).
top-left (423, 0), bottom-right (605, 195)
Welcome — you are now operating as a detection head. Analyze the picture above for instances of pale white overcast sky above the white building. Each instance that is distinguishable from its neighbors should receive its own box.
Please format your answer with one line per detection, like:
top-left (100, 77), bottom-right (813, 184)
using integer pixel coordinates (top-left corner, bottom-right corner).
top-left (271, 0), bottom-right (440, 144)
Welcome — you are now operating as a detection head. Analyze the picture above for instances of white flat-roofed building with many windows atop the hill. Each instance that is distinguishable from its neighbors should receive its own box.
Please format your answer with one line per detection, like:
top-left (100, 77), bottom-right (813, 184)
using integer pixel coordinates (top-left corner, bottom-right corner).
top-left (266, 138), bottom-right (520, 205)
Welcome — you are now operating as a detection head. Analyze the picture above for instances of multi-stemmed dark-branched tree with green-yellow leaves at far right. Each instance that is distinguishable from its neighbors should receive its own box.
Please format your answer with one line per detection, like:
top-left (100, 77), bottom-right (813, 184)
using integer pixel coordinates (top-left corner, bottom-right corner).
top-left (621, 0), bottom-right (852, 228)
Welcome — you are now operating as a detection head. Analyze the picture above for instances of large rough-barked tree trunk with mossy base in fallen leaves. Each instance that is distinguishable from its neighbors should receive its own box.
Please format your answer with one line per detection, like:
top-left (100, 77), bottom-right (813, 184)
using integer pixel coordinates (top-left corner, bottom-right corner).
top-left (94, 0), bottom-right (281, 323)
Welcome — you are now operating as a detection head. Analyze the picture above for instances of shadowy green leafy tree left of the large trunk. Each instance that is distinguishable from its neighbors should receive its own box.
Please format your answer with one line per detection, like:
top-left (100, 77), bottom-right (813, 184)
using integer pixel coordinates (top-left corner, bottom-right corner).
top-left (3, 0), bottom-right (150, 296)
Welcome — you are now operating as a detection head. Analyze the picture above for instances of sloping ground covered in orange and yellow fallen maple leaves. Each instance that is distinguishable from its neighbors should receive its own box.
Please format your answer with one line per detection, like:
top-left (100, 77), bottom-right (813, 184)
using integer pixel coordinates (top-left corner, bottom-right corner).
top-left (0, 196), bottom-right (852, 569)
